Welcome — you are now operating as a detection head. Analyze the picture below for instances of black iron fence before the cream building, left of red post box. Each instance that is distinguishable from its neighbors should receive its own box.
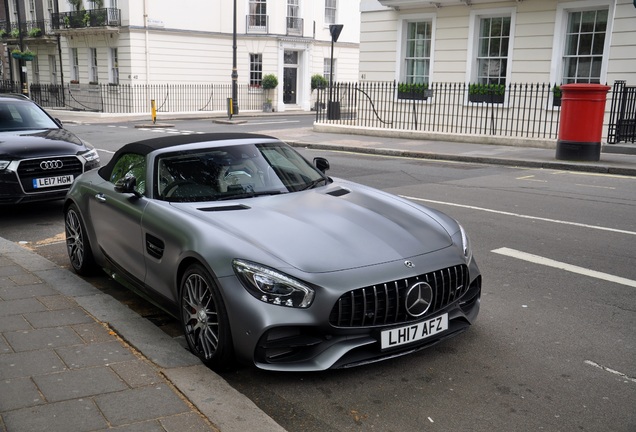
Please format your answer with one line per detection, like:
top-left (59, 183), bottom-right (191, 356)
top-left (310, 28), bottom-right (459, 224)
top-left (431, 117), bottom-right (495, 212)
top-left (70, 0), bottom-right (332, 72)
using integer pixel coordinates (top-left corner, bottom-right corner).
top-left (315, 82), bottom-right (560, 139)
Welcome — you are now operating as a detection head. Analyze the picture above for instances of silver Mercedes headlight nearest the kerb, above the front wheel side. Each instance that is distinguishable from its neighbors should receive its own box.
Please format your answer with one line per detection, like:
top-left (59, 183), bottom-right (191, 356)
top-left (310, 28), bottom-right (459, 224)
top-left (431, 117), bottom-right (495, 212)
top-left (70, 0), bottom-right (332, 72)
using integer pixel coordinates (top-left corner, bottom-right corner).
top-left (232, 259), bottom-right (314, 308)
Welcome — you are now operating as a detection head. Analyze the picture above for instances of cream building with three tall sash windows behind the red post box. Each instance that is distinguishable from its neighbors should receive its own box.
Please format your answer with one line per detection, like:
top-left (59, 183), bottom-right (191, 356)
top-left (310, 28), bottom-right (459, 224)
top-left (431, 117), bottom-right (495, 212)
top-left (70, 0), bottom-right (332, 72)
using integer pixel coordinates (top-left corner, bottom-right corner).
top-left (359, 0), bottom-right (636, 85)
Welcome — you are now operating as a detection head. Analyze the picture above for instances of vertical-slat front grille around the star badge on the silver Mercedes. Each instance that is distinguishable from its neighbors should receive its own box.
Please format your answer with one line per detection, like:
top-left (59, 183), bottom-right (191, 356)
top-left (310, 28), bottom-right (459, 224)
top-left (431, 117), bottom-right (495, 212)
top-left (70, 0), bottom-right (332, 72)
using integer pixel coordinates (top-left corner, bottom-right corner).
top-left (329, 265), bottom-right (469, 327)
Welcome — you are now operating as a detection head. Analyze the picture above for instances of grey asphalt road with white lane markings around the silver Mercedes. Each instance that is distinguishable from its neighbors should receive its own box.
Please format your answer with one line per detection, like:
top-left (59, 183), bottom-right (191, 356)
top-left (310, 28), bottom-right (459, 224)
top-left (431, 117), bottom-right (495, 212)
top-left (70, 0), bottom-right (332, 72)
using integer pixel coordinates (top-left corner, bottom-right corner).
top-left (0, 119), bottom-right (636, 432)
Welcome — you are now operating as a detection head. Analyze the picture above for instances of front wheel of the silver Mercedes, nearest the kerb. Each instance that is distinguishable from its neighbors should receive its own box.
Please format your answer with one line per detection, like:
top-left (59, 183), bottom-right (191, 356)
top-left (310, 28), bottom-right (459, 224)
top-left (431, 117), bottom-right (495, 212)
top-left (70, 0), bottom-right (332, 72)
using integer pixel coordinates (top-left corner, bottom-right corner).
top-left (179, 264), bottom-right (234, 371)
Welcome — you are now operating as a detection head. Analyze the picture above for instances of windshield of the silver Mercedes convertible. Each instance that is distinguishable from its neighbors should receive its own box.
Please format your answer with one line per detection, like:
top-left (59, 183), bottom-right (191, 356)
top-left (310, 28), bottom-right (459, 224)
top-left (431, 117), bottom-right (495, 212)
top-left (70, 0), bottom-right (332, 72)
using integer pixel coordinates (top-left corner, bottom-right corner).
top-left (155, 143), bottom-right (327, 202)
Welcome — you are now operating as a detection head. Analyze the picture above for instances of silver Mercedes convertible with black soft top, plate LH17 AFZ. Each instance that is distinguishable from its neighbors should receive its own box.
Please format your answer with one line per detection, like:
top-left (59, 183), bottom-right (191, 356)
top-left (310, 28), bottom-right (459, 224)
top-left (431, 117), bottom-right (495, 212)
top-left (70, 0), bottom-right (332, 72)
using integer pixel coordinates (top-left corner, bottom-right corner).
top-left (64, 133), bottom-right (481, 371)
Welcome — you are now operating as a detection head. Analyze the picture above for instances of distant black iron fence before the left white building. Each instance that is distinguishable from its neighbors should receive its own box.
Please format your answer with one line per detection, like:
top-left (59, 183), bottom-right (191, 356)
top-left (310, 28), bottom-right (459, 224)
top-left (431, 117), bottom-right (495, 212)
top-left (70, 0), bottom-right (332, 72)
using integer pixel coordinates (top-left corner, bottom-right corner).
top-left (21, 83), bottom-right (264, 114)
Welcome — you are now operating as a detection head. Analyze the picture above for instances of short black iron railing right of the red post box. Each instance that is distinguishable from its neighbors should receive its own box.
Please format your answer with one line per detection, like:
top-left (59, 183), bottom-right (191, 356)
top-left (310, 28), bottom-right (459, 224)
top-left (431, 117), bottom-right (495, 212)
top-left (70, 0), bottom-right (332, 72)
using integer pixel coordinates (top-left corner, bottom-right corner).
top-left (607, 80), bottom-right (636, 144)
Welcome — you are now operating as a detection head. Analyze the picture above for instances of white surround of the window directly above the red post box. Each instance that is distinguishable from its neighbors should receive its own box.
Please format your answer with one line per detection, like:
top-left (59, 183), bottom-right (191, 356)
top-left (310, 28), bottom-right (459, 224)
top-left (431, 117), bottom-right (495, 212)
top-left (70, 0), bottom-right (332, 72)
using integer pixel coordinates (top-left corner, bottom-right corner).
top-left (550, 0), bottom-right (615, 84)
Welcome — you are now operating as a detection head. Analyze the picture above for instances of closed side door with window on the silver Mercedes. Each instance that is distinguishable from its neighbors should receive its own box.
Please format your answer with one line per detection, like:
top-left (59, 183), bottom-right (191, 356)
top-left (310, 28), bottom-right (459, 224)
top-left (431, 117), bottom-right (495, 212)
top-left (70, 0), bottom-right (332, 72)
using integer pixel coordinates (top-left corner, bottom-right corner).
top-left (89, 154), bottom-right (148, 284)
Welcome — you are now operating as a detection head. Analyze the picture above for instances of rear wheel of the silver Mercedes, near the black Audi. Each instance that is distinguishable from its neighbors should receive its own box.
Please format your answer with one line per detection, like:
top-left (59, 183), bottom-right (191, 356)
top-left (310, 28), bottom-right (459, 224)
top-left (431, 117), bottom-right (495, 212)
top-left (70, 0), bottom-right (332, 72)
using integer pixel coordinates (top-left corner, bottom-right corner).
top-left (64, 204), bottom-right (99, 276)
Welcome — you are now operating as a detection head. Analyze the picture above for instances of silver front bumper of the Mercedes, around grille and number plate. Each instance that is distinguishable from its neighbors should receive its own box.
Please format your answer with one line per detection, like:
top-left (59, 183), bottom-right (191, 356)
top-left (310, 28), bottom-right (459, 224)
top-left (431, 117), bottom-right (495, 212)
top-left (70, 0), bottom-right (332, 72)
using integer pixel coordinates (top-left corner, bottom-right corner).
top-left (222, 251), bottom-right (482, 372)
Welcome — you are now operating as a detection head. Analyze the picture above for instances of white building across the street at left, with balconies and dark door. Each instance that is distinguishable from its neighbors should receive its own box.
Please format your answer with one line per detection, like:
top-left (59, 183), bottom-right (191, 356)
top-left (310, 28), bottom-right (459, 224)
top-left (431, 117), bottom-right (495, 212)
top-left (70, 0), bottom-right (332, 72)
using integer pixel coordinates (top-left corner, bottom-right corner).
top-left (0, 0), bottom-right (360, 111)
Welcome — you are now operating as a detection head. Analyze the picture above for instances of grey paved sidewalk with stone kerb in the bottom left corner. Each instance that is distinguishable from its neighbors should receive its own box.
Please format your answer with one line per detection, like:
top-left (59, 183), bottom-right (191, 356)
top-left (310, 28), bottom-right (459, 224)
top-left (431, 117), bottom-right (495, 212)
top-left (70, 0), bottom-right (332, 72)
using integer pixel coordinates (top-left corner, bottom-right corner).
top-left (0, 238), bottom-right (284, 432)
